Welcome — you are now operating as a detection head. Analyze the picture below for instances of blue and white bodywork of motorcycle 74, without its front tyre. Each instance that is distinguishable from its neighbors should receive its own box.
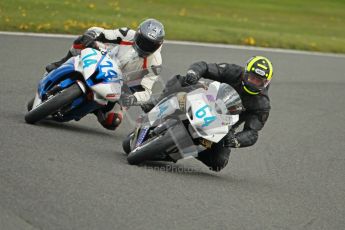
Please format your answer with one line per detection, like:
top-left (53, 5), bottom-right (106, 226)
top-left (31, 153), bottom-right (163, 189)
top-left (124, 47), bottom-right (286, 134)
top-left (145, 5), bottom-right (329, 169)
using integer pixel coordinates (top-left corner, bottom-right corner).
top-left (32, 48), bottom-right (123, 121)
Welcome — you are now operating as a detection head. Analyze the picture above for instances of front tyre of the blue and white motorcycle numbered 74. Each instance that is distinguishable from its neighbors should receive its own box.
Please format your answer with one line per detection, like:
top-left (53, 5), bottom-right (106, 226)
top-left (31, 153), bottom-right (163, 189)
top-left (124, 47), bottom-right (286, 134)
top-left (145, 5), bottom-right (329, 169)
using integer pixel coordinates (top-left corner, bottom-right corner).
top-left (25, 84), bottom-right (83, 124)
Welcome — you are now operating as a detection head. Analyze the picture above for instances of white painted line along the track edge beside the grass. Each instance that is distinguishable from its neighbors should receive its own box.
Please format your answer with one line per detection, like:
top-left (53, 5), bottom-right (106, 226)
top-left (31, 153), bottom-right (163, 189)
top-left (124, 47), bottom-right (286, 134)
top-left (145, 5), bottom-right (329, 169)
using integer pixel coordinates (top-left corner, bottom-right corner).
top-left (0, 31), bottom-right (345, 58)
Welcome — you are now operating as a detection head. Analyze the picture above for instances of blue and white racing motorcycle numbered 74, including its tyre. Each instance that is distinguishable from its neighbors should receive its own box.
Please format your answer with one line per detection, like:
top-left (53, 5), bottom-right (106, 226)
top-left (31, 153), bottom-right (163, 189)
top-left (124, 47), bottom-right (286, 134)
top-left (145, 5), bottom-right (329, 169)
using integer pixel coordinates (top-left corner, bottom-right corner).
top-left (25, 44), bottom-right (123, 124)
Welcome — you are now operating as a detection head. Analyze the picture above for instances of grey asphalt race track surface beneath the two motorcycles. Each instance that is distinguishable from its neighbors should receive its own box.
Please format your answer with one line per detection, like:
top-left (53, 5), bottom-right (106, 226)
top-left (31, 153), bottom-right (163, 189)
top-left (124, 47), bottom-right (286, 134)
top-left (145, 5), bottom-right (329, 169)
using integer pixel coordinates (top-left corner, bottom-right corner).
top-left (0, 35), bottom-right (345, 230)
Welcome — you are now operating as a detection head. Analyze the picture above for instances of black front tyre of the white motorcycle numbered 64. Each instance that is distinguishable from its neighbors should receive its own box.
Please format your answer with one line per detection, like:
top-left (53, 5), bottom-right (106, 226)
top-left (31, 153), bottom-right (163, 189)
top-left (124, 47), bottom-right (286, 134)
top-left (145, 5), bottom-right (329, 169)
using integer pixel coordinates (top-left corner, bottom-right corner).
top-left (127, 125), bottom-right (185, 165)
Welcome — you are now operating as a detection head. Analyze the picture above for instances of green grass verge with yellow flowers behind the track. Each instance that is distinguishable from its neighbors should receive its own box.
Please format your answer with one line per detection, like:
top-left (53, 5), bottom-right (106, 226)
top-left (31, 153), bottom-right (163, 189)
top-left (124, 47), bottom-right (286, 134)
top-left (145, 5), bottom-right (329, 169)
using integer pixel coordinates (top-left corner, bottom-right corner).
top-left (0, 0), bottom-right (345, 53)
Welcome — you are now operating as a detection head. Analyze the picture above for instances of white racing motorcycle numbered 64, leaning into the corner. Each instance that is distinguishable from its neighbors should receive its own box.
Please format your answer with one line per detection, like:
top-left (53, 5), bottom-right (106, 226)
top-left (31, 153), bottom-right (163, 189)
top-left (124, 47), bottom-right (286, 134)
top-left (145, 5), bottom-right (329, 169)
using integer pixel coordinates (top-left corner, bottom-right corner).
top-left (122, 81), bottom-right (243, 164)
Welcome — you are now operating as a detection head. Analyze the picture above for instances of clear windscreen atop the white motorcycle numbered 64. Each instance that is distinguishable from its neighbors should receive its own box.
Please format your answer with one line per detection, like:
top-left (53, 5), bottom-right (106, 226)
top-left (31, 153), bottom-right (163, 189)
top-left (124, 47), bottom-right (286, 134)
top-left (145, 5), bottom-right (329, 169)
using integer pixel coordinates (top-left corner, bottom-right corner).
top-left (215, 83), bottom-right (244, 115)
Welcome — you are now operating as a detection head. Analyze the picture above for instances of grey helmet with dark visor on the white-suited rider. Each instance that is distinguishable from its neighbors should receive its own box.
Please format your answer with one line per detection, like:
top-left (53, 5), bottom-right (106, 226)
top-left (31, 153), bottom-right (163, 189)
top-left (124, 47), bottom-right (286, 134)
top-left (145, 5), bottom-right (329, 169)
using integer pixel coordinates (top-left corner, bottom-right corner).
top-left (133, 19), bottom-right (165, 57)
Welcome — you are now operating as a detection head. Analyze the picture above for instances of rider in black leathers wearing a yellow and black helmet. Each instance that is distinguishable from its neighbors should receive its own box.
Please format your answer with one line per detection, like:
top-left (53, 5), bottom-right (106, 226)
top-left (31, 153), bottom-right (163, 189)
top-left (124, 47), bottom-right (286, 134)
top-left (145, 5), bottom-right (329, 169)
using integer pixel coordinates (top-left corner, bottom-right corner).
top-left (157, 56), bottom-right (273, 171)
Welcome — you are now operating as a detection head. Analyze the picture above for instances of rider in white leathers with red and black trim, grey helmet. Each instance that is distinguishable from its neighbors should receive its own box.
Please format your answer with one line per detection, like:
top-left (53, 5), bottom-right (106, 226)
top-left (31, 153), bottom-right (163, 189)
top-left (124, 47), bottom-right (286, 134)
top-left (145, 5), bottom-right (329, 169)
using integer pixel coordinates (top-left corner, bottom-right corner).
top-left (46, 19), bottom-right (165, 130)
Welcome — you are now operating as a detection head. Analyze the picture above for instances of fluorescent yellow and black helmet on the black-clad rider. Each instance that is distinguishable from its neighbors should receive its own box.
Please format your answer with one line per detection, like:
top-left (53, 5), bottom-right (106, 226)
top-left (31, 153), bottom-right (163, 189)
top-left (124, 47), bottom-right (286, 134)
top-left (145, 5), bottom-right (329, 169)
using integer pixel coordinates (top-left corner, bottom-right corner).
top-left (242, 56), bottom-right (273, 95)
